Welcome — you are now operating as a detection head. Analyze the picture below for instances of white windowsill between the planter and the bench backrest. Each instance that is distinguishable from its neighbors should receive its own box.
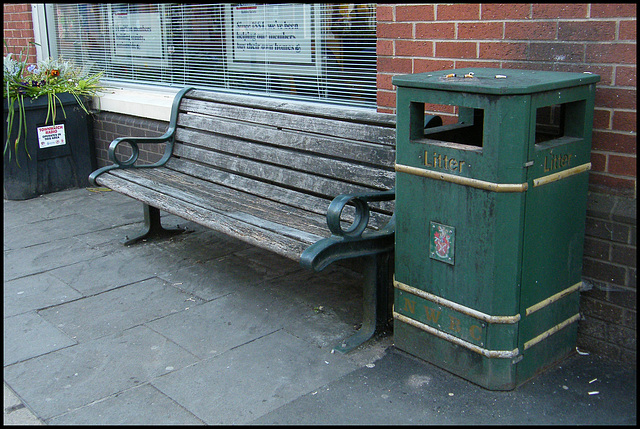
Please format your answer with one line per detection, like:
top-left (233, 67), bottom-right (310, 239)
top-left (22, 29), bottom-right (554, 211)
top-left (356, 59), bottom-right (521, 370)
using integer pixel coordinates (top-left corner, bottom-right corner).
top-left (93, 86), bottom-right (181, 122)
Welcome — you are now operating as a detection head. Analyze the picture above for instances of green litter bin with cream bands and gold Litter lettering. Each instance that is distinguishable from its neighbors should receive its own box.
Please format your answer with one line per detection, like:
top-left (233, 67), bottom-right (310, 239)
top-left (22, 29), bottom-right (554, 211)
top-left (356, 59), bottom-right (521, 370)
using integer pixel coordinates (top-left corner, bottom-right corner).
top-left (393, 68), bottom-right (600, 390)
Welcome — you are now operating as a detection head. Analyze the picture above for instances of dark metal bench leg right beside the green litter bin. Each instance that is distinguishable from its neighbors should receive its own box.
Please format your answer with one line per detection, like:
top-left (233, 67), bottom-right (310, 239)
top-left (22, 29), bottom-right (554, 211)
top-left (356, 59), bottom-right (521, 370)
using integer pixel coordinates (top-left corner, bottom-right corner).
top-left (334, 253), bottom-right (389, 353)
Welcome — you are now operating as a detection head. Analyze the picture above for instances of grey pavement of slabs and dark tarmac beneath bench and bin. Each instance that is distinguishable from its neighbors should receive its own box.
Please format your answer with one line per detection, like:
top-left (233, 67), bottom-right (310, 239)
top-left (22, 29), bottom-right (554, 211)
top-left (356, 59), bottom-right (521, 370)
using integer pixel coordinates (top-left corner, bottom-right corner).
top-left (3, 188), bottom-right (636, 425)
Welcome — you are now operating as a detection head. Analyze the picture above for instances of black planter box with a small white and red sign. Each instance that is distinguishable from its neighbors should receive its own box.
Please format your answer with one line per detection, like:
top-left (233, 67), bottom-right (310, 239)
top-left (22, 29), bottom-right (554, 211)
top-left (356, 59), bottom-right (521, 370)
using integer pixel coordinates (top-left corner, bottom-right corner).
top-left (3, 93), bottom-right (96, 200)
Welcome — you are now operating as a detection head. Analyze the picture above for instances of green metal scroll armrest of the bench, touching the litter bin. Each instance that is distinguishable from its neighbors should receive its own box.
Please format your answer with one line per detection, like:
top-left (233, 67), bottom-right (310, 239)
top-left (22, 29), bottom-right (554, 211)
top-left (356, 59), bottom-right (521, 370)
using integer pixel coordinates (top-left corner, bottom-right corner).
top-left (327, 189), bottom-right (396, 238)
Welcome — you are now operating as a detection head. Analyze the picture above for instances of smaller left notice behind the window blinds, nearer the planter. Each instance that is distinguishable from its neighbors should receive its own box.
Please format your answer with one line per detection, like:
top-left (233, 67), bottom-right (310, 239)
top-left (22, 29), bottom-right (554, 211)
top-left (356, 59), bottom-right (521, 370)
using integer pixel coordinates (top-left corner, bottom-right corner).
top-left (113, 12), bottom-right (162, 58)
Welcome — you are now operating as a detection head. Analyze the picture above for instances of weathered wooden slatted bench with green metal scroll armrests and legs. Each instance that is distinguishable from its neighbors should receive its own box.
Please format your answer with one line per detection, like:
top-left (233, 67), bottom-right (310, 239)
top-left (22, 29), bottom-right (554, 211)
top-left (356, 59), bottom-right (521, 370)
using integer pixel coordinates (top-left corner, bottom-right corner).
top-left (89, 88), bottom-right (395, 352)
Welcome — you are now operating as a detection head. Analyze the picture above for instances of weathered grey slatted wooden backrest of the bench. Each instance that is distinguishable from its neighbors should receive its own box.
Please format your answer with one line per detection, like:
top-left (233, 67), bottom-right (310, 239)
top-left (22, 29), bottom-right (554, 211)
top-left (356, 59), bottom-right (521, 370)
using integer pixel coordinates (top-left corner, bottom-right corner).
top-left (167, 90), bottom-right (395, 226)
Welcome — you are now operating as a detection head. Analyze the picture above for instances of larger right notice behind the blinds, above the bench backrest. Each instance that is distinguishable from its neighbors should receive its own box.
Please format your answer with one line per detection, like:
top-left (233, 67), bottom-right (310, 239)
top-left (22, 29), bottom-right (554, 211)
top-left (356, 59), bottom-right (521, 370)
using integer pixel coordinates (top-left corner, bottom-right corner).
top-left (231, 3), bottom-right (314, 65)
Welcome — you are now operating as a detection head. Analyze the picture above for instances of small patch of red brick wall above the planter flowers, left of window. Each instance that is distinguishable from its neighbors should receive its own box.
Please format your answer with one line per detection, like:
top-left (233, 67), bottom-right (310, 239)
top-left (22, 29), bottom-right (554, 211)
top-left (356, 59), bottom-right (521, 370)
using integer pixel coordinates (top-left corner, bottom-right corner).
top-left (3, 3), bottom-right (36, 63)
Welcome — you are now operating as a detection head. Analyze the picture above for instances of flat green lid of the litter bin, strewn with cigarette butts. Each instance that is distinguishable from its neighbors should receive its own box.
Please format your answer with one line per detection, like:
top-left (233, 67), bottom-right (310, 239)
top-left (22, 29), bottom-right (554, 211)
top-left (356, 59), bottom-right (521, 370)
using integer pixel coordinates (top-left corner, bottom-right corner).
top-left (392, 68), bottom-right (600, 94)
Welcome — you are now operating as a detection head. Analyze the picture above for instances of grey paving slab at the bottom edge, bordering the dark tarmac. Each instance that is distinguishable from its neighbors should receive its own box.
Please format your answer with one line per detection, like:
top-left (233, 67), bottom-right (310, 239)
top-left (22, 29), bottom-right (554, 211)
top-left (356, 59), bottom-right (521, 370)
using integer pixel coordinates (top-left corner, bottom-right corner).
top-left (152, 331), bottom-right (356, 425)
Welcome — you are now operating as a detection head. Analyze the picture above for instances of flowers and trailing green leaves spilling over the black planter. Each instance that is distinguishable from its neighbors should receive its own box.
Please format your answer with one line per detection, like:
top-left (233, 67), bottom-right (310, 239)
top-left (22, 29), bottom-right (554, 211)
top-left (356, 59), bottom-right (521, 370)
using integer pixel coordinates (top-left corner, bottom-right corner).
top-left (3, 46), bottom-right (104, 166)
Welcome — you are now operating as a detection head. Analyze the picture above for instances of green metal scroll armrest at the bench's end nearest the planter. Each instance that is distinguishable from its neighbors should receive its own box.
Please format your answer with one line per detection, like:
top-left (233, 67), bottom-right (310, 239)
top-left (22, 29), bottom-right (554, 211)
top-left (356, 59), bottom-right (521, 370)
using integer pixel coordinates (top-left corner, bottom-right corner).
top-left (89, 87), bottom-right (193, 186)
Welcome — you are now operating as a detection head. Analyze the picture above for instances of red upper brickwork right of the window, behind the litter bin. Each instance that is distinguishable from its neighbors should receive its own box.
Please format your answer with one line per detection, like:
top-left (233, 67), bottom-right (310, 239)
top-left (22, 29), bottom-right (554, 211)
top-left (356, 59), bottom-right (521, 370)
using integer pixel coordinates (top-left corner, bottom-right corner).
top-left (377, 3), bottom-right (637, 198)
